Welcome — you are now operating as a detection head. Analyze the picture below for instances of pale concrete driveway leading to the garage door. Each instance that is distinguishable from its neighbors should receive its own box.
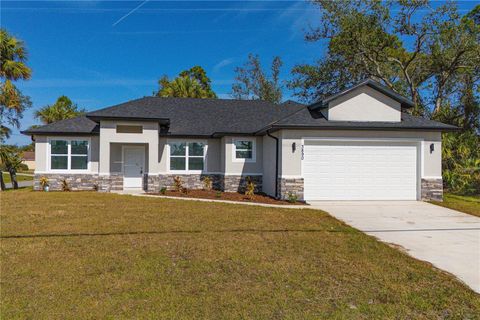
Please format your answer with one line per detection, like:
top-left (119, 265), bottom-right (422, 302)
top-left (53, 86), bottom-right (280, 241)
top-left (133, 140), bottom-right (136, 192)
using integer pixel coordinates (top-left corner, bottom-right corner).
top-left (310, 201), bottom-right (480, 293)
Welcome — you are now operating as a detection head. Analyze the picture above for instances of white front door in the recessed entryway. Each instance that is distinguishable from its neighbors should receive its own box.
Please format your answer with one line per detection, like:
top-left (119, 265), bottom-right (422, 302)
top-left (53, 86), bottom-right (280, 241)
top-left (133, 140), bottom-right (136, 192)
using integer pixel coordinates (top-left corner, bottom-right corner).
top-left (123, 147), bottom-right (145, 189)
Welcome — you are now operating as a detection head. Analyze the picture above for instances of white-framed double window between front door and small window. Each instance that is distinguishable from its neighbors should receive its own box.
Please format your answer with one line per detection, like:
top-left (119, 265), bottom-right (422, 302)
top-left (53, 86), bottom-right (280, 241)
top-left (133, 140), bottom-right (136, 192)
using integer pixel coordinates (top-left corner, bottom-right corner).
top-left (169, 141), bottom-right (205, 171)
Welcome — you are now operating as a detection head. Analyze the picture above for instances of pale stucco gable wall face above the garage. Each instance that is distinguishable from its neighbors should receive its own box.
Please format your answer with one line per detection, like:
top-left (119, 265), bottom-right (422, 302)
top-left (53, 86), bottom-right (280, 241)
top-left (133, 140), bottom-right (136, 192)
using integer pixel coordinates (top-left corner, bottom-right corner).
top-left (327, 86), bottom-right (401, 122)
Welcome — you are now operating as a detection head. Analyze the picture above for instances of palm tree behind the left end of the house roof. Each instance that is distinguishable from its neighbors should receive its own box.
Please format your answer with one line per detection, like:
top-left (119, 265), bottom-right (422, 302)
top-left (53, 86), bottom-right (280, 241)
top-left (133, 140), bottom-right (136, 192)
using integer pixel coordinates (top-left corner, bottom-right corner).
top-left (35, 96), bottom-right (85, 124)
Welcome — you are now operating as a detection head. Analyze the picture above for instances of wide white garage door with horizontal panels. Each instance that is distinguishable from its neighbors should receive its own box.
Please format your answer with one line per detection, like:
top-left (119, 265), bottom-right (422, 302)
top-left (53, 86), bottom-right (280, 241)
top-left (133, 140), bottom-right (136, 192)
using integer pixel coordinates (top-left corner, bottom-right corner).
top-left (303, 141), bottom-right (417, 201)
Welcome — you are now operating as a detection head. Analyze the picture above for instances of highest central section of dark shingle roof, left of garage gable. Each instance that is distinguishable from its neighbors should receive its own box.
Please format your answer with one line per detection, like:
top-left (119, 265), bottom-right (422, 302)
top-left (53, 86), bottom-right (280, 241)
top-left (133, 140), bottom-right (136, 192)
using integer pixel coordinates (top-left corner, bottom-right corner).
top-left (87, 97), bottom-right (304, 136)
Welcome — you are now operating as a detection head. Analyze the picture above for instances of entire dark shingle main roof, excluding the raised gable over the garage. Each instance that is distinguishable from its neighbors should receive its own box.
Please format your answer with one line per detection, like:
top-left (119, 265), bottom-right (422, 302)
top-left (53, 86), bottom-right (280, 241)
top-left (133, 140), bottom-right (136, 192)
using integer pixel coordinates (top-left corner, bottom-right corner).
top-left (23, 97), bottom-right (456, 136)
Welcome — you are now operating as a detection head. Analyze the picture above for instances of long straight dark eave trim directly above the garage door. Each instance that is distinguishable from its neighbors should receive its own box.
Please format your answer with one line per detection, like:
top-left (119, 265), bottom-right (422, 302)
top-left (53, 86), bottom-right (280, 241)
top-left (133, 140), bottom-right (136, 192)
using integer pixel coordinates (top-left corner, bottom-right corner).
top-left (267, 125), bottom-right (461, 132)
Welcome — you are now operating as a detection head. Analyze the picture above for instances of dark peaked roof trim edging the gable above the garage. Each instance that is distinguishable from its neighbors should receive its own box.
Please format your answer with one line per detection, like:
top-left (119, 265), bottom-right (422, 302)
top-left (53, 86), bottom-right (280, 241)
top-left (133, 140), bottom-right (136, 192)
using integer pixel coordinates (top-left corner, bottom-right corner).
top-left (308, 79), bottom-right (415, 110)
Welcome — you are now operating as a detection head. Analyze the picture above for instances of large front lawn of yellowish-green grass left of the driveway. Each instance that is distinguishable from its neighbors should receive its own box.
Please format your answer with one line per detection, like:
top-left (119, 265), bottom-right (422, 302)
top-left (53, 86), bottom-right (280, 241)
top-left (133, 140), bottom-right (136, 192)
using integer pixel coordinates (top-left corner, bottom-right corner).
top-left (0, 191), bottom-right (480, 319)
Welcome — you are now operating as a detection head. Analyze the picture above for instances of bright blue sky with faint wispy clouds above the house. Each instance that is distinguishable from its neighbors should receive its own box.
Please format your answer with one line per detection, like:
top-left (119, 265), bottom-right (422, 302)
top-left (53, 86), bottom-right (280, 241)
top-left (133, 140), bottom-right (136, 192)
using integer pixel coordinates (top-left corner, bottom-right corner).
top-left (0, 0), bottom-right (478, 144)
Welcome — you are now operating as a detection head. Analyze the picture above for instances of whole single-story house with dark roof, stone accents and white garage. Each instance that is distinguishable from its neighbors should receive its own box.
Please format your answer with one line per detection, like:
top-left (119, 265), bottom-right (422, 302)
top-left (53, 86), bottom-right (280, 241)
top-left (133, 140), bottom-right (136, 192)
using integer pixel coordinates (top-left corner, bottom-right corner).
top-left (23, 80), bottom-right (457, 201)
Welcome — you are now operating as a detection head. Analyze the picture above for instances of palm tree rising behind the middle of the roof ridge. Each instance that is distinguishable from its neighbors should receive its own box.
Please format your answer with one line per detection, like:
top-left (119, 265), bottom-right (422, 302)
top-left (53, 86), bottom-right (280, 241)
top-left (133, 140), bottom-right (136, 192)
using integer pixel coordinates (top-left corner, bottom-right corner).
top-left (158, 76), bottom-right (210, 99)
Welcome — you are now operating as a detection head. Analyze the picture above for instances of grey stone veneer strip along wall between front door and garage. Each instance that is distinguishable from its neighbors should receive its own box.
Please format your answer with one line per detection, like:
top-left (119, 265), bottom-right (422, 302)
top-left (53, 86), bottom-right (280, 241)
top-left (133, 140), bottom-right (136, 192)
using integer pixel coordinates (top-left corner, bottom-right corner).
top-left (147, 174), bottom-right (262, 192)
